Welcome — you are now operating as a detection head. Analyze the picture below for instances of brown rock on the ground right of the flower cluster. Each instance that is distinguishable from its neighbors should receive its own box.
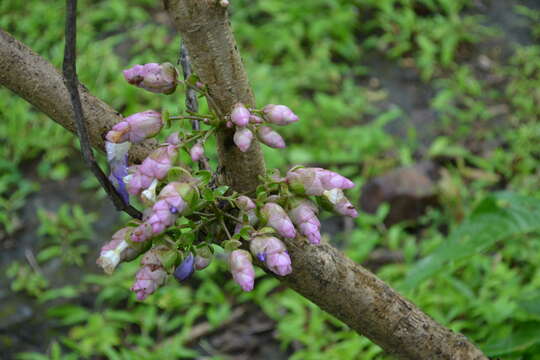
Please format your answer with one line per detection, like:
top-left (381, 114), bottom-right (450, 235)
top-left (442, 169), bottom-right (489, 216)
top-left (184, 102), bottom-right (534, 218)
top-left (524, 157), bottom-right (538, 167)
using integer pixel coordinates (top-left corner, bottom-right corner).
top-left (360, 161), bottom-right (438, 226)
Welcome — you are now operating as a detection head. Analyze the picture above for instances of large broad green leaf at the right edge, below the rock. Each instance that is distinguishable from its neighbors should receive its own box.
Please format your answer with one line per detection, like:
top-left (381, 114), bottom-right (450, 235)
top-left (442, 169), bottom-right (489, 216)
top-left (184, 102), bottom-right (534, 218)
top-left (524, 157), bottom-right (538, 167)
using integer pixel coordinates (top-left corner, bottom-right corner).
top-left (404, 192), bottom-right (540, 290)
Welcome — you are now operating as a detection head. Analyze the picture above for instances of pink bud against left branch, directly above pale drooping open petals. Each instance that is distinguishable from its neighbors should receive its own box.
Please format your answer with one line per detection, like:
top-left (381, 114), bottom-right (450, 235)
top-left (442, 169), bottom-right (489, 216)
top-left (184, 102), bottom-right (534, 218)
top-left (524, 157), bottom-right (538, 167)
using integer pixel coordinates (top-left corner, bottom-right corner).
top-left (106, 110), bottom-right (163, 144)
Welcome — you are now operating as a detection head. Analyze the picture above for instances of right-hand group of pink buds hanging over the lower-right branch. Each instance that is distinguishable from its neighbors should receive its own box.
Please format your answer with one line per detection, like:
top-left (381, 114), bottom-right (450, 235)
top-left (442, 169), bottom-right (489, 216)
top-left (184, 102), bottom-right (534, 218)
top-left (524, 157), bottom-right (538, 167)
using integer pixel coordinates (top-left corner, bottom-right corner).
top-left (225, 167), bottom-right (358, 291)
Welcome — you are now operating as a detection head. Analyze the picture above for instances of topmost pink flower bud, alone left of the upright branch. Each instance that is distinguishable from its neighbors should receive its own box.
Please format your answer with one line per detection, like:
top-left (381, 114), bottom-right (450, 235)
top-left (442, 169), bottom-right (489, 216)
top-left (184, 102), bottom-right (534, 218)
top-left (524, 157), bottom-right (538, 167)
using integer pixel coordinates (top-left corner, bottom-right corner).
top-left (124, 63), bottom-right (178, 94)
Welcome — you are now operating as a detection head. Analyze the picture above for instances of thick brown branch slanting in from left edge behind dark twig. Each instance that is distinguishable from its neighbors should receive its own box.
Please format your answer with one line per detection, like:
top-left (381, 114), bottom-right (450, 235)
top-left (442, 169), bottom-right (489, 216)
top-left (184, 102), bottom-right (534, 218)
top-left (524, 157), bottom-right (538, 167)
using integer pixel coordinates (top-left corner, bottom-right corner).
top-left (0, 29), bottom-right (155, 162)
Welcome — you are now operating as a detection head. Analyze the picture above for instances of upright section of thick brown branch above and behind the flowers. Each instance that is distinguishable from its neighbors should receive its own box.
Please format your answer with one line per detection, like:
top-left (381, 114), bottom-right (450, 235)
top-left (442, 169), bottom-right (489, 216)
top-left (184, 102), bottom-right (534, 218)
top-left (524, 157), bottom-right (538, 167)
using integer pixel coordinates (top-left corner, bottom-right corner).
top-left (164, 0), bottom-right (265, 193)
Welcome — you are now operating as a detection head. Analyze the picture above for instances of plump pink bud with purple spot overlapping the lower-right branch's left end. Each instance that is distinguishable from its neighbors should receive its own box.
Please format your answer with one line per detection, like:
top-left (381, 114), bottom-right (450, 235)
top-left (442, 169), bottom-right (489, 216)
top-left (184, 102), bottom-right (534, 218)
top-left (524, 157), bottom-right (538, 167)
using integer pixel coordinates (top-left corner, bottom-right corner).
top-left (249, 236), bottom-right (292, 276)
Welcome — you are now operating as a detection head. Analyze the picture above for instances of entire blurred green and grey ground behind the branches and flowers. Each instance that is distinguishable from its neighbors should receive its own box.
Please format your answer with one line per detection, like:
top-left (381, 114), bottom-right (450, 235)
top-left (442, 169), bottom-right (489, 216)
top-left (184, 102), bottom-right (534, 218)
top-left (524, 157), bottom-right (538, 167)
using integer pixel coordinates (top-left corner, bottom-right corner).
top-left (0, 0), bottom-right (540, 360)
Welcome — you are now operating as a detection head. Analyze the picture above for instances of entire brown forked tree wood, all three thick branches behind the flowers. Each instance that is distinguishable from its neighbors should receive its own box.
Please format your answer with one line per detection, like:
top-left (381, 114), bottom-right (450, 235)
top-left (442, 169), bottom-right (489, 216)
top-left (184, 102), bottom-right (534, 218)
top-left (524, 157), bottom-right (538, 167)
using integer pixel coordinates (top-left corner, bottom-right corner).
top-left (0, 6), bottom-right (487, 360)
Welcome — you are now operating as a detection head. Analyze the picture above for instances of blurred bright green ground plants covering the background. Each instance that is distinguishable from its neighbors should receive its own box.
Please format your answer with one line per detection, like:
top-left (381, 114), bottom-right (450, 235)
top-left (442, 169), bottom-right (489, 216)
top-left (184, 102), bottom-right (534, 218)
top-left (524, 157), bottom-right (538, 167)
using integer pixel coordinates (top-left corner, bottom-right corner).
top-left (0, 0), bottom-right (540, 359)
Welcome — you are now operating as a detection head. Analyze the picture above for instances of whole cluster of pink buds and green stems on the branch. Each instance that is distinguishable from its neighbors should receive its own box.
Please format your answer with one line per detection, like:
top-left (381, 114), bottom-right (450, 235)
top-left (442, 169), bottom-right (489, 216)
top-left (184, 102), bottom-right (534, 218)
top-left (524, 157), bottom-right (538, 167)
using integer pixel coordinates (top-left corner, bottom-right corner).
top-left (97, 63), bottom-right (357, 300)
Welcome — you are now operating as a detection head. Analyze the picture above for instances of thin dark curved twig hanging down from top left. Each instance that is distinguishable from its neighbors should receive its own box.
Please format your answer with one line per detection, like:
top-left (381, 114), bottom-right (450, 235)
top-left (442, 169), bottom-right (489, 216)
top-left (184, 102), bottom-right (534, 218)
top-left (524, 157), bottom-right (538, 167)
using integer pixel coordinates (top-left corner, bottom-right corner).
top-left (62, 0), bottom-right (142, 219)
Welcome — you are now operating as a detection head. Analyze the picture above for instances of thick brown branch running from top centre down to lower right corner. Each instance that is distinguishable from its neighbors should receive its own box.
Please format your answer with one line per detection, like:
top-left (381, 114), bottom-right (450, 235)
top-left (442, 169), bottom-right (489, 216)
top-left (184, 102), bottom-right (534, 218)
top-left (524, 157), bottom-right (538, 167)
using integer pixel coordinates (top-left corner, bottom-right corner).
top-left (164, 0), bottom-right (487, 360)
